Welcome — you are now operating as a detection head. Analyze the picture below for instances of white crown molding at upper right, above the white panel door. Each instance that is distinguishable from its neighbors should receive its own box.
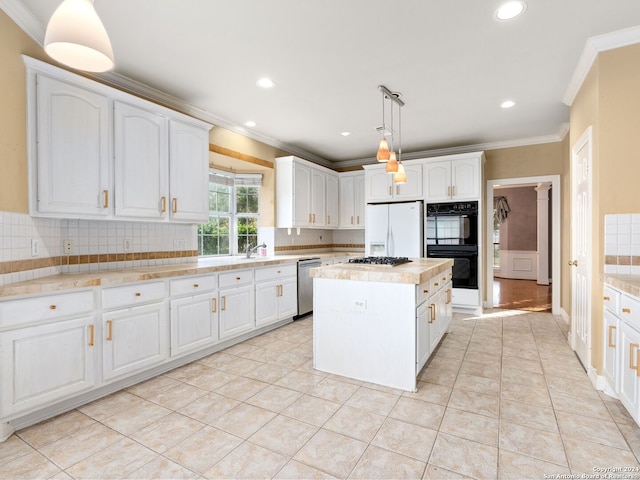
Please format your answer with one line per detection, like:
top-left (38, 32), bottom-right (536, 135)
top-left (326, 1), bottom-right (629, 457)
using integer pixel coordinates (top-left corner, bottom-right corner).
top-left (562, 25), bottom-right (640, 106)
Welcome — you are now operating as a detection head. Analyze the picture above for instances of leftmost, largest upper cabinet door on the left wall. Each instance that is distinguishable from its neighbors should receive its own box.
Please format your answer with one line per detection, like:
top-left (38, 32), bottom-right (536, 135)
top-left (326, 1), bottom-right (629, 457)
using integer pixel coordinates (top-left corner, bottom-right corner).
top-left (34, 75), bottom-right (112, 218)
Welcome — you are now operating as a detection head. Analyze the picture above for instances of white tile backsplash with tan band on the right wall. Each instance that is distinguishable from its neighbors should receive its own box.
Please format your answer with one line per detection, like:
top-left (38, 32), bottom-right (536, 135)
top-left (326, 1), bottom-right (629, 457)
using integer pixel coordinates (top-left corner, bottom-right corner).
top-left (604, 214), bottom-right (640, 275)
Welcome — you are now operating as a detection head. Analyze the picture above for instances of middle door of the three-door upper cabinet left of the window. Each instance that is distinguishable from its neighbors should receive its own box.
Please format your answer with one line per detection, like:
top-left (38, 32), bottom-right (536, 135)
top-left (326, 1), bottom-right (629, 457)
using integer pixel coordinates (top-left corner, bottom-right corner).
top-left (114, 102), bottom-right (169, 219)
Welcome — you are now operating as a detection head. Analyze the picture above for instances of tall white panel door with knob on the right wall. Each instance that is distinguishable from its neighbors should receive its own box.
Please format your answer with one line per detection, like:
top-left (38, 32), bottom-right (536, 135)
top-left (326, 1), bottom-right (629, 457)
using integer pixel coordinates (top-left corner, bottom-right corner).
top-left (569, 127), bottom-right (592, 371)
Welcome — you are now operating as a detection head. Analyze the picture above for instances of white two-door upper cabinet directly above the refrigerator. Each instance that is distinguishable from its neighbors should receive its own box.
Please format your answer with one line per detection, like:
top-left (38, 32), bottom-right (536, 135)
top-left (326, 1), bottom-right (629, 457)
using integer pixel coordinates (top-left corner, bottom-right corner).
top-left (364, 162), bottom-right (423, 203)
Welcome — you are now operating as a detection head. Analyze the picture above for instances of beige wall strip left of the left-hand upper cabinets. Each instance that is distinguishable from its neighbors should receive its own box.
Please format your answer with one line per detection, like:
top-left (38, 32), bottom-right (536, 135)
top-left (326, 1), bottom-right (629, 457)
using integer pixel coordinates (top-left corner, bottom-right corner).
top-left (0, 10), bottom-right (47, 213)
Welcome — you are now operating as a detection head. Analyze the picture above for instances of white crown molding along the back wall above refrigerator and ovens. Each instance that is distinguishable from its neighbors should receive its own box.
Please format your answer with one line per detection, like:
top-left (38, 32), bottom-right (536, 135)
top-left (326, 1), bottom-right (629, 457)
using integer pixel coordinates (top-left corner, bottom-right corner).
top-left (331, 123), bottom-right (569, 170)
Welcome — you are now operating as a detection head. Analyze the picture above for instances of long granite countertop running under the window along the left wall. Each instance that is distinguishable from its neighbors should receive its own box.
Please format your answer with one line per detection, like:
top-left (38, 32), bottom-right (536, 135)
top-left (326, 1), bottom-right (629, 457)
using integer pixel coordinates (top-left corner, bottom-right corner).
top-left (0, 252), bottom-right (362, 298)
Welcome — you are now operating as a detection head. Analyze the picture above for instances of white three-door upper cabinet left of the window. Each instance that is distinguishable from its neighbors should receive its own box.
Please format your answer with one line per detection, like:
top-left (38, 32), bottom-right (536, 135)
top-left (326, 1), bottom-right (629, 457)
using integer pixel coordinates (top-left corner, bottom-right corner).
top-left (23, 57), bottom-right (211, 223)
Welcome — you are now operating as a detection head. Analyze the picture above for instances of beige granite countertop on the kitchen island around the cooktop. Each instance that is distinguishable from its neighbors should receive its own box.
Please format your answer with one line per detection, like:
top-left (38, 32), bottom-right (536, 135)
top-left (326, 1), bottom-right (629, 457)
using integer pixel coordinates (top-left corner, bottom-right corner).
top-left (311, 258), bottom-right (453, 285)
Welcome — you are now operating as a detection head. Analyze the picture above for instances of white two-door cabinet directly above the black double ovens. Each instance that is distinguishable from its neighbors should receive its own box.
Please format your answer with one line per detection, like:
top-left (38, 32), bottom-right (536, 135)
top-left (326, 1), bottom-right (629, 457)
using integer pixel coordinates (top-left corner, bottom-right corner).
top-left (424, 152), bottom-right (483, 203)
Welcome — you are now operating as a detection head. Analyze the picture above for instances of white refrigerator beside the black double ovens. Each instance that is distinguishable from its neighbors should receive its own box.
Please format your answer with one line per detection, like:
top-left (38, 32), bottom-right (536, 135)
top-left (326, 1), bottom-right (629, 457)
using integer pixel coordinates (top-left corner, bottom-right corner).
top-left (364, 202), bottom-right (424, 258)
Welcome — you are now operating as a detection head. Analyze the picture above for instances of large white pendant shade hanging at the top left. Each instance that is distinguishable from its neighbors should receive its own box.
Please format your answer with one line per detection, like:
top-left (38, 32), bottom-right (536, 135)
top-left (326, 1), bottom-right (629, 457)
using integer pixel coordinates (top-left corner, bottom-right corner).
top-left (44, 0), bottom-right (115, 72)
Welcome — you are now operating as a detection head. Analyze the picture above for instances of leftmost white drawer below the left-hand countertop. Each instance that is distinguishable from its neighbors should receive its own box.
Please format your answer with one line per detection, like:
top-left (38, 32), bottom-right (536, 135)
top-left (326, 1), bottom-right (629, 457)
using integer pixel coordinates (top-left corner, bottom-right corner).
top-left (0, 290), bottom-right (94, 328)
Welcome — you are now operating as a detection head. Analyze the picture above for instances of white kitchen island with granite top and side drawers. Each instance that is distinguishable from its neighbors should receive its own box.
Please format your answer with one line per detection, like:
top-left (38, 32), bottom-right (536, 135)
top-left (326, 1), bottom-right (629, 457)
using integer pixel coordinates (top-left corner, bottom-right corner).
top-left (311, 258), bottom-right (453, 391)
